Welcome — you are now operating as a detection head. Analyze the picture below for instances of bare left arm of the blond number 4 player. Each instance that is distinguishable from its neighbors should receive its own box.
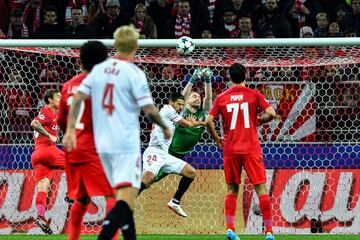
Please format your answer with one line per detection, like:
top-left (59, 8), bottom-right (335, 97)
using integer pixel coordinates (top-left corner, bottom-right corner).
top-left (63, 92), bottom-right (89, 151)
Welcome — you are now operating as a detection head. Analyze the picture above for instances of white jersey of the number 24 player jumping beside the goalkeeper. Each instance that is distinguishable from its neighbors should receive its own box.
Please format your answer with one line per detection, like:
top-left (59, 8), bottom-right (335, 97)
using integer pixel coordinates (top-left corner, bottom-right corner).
top-left (149, 105), bottom-right (183, 152)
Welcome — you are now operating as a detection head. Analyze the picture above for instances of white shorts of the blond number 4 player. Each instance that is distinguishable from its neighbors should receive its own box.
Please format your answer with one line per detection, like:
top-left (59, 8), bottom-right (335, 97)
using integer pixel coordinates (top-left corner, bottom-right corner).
top-left (99, 152), bottom-right (141, 189)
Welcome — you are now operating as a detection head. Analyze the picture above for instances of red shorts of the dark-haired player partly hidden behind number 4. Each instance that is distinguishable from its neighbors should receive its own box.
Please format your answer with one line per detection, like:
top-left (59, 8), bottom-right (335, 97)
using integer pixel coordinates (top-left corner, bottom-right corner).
top-left (66, 159), bottom-right (114, 199)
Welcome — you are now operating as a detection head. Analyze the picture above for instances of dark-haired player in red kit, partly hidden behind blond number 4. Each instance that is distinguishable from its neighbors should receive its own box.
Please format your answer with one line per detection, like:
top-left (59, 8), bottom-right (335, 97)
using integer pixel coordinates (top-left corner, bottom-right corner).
top-left (58, 41), bottom-right (117, 240)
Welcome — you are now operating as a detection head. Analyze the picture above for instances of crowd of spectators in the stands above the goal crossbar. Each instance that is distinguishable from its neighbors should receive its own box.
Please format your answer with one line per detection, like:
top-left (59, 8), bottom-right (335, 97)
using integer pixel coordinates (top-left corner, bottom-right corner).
top-left (0, 0), bottom-right (360, 39)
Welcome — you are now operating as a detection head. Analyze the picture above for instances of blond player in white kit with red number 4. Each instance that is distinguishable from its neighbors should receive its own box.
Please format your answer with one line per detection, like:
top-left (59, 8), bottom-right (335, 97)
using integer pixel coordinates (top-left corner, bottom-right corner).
top-left (64, 26), bottom-right (171, 240)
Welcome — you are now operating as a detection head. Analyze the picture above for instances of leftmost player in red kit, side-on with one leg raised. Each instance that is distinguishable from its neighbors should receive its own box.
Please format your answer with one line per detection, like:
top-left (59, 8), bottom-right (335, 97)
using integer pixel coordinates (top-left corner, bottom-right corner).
top-left (31, 89), bottom-right (65, 234)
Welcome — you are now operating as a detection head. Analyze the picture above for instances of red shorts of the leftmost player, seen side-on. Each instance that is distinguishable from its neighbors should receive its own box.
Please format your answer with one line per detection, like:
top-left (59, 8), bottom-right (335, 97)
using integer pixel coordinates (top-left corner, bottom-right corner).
top-left (31, 145), bottom-right (65, 182)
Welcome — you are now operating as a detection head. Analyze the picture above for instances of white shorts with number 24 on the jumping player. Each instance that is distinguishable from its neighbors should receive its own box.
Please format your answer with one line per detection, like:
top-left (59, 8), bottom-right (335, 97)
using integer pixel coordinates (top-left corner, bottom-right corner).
top-left (143, 147), bottom-right (187, 176)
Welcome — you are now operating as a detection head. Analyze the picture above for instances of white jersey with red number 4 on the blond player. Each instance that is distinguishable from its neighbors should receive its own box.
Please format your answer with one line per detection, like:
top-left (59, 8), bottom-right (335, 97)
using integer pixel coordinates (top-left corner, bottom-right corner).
top-left (79, 58), bottom-right (153, 153)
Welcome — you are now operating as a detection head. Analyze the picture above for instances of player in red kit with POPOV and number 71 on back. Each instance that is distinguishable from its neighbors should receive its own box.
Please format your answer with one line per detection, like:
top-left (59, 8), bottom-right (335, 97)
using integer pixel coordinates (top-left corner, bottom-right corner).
top-left (207, 63), bottom-right (276, 240)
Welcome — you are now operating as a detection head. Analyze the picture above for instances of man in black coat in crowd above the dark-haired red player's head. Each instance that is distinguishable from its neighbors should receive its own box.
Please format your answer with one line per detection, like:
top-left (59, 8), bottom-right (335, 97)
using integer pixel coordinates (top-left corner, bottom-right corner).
top-left (64, 7), bottom-right (96, 39)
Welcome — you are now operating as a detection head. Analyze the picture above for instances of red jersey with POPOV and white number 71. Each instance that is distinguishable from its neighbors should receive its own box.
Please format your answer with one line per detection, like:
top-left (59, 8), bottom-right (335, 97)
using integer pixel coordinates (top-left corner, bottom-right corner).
top-left (209, 86), bottom-right (270, 154)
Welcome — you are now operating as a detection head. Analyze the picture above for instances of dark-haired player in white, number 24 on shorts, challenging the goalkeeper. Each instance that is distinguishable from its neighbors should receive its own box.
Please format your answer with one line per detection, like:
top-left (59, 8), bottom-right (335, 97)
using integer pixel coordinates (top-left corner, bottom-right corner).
top-left (140, 93), bottom-right (204, 217)
